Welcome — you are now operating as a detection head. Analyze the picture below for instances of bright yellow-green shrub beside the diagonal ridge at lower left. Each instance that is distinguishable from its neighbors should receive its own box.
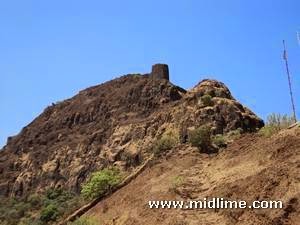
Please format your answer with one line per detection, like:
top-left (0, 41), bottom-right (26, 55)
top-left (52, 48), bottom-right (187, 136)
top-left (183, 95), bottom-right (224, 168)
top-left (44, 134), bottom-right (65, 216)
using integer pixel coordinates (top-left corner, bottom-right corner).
top-left (81, 168), bottom-right (121, 199)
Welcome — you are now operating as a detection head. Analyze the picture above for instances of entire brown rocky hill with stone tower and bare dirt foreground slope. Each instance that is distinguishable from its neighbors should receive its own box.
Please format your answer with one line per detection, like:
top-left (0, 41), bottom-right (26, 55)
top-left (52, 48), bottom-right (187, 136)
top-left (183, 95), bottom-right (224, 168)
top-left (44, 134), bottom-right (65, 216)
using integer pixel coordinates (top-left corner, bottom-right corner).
top-left (0, 64), bottom-right (286, 225)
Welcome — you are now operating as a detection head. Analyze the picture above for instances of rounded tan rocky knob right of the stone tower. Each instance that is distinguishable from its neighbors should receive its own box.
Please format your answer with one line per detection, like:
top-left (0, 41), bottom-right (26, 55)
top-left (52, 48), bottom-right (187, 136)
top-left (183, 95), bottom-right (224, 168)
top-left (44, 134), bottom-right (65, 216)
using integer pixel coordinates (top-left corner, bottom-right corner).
top-left (185, 79), bottom-right (264, 134)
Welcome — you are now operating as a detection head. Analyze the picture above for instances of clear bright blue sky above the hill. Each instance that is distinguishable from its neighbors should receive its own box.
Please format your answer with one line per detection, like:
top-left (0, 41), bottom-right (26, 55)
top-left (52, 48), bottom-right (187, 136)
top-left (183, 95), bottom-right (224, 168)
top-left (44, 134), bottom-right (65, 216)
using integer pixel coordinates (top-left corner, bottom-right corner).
top-left (0, 0), bottom-right (300, 146)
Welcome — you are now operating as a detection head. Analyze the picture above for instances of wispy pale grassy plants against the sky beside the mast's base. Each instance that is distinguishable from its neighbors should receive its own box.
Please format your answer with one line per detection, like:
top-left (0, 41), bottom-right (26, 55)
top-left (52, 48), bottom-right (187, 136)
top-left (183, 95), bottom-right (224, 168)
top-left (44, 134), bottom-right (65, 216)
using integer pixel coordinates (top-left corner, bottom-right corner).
top-left (259, 113), bottom-right (295, 137)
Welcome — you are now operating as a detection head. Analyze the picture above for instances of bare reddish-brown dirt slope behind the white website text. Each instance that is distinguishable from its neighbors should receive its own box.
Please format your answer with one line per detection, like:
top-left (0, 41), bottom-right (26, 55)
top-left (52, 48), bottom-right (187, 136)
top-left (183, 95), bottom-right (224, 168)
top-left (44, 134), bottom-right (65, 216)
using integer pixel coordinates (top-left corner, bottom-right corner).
top-left (86, 127), bottom-right (300, 225)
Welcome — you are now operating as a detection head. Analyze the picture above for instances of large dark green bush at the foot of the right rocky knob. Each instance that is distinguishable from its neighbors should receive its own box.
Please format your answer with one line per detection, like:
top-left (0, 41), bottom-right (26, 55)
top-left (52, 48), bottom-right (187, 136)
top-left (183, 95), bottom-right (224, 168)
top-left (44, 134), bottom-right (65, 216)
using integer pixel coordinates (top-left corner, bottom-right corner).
top-left (189, 125), bottom-right (212, 151)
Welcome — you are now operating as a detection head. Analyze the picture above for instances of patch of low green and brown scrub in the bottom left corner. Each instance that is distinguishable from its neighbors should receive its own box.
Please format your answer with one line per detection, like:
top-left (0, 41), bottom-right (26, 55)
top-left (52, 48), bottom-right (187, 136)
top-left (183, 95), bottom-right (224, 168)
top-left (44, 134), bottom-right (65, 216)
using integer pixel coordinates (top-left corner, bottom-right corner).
top-left (0, 188), bottom-right (84, 225)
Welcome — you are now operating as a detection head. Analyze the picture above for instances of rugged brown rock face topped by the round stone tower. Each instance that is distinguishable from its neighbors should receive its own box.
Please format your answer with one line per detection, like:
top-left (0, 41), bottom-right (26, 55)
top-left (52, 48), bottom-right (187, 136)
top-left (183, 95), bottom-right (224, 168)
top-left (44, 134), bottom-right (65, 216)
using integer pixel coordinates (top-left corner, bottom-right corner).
top-left (0, 64), bottom-right (263, 196)
